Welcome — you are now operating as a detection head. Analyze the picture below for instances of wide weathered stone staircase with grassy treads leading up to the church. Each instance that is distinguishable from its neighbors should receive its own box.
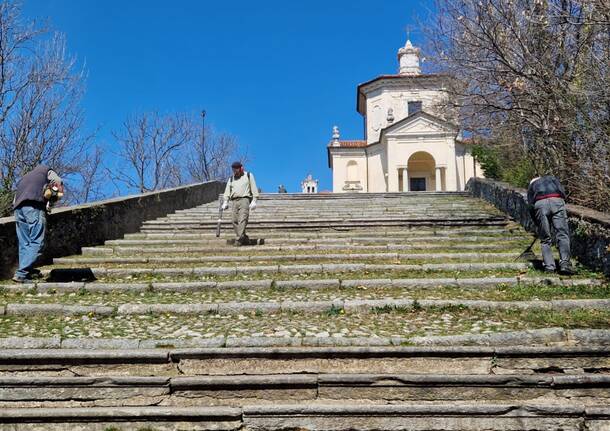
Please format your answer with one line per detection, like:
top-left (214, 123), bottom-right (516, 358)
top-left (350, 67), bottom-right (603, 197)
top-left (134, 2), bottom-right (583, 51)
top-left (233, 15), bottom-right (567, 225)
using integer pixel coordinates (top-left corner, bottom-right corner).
top-left (0, 193), bottom-right (610, 431)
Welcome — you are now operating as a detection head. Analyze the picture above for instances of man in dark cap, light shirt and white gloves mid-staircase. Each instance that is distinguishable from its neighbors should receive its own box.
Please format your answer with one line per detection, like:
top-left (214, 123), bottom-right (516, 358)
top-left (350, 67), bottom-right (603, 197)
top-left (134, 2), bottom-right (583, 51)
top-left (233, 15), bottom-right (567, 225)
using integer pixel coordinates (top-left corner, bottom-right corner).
top-left (222, 162), bottom-right (259, 245)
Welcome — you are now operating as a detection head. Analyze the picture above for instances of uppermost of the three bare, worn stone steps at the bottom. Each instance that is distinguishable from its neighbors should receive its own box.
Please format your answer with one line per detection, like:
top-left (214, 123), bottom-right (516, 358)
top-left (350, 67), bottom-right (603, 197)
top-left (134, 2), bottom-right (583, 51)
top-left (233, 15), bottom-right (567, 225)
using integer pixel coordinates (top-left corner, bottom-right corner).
top-left (0, 346), bottom-right (610, 377)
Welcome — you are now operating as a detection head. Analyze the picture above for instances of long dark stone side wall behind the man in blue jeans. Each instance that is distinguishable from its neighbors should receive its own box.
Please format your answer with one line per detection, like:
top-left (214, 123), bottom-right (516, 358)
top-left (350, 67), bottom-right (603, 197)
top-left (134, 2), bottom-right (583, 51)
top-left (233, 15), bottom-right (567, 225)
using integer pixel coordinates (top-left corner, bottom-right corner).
top-left (0, 181), bottom-right (224, 278)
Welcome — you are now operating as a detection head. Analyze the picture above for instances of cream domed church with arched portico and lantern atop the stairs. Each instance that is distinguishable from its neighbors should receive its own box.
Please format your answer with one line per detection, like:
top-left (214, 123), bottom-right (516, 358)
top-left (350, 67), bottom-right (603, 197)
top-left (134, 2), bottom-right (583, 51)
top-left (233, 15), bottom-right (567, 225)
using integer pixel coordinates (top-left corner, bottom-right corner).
top-left (327, 40), bottom-right (482, 193)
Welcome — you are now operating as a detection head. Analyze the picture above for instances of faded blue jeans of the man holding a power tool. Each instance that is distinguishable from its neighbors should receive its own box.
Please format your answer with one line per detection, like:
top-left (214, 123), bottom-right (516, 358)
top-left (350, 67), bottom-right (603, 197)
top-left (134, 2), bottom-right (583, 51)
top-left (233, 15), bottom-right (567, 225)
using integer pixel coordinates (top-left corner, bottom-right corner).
top-left (15, 206), bottom-right (47, 279)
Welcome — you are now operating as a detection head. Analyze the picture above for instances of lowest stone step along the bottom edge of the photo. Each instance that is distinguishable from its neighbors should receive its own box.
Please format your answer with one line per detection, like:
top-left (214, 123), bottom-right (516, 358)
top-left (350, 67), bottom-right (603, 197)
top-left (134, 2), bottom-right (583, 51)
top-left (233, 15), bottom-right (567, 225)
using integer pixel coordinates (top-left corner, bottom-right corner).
top-left (0, 402), bottom-right (610, 431)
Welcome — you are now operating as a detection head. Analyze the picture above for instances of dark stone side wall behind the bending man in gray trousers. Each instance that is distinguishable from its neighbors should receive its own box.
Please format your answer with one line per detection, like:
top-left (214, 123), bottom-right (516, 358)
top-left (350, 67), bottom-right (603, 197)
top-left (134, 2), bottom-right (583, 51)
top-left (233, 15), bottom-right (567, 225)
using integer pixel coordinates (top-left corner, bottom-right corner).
top-left (466, 178), bottom-right (610, 276)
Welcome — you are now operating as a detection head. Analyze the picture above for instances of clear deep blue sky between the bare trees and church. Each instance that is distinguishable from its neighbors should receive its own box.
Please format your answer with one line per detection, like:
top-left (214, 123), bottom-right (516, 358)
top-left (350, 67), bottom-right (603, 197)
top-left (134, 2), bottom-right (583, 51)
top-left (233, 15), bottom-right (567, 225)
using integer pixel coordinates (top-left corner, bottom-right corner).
top-left (23, 0), bottom-right (432, 192)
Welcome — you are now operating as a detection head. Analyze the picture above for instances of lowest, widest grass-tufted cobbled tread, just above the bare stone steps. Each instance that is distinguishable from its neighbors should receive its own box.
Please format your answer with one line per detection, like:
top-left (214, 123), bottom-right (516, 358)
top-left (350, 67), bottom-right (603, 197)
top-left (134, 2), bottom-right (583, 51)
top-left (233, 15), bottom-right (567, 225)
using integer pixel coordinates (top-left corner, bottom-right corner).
top-left (0, 306), bottom-right (610, 339)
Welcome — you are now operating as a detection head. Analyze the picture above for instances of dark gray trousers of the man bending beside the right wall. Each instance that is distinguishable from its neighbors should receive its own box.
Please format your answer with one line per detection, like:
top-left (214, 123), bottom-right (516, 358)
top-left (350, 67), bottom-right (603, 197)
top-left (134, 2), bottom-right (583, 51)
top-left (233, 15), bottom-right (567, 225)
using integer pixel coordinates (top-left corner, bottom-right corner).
top-left (534, 198), bottom-right (570, 271)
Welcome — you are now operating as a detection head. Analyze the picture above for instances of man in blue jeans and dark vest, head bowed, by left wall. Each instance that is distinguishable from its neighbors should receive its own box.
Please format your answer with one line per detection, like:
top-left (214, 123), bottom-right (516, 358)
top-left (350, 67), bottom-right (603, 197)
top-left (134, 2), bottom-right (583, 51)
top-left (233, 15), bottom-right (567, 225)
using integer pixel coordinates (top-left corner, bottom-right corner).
top-left (13, 165), bottom-right (62, 283)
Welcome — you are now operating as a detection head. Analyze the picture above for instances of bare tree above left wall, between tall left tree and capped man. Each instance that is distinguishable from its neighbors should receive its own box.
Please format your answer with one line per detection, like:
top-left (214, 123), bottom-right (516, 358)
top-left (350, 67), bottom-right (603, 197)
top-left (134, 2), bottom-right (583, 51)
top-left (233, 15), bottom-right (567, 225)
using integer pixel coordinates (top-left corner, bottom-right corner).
top-left (110, 112), bottom-right (193, 193)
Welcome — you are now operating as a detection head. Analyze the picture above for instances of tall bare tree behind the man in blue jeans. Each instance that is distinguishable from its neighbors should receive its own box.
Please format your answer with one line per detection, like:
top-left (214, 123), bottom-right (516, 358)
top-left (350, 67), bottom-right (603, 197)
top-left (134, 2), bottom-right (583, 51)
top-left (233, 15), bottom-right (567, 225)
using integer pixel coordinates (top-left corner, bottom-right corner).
top-left (0, 1), bottom-right (100, 214)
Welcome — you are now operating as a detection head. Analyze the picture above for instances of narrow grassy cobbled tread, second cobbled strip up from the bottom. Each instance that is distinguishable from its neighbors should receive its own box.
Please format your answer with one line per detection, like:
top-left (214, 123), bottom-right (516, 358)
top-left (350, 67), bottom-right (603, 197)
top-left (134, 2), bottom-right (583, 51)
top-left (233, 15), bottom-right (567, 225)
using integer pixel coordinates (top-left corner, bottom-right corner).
top-left (0, 284), bottom-right (610, 305)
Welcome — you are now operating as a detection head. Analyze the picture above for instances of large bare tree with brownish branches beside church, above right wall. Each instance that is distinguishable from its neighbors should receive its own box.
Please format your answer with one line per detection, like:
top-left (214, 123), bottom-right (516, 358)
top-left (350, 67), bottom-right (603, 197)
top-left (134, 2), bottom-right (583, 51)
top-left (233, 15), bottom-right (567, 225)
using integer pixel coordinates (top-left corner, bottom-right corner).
top-left (429, 0), bottom-right (610, 211)
